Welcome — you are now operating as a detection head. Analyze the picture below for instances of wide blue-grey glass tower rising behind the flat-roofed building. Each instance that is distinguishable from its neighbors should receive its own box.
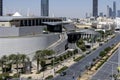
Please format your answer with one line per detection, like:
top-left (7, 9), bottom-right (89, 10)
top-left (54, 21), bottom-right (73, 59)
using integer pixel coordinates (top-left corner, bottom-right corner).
top-left (41, 0), bottom-right (49, 16)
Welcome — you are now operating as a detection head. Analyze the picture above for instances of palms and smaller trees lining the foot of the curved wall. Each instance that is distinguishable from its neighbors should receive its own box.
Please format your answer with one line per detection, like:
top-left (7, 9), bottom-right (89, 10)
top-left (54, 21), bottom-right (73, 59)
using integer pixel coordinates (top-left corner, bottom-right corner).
top-left (0, 49), bottom-right (78, 77)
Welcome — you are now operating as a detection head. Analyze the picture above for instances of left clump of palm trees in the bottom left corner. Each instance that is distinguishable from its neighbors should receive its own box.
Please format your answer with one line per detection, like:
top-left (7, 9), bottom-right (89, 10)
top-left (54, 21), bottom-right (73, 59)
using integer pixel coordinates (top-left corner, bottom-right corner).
top-left (0, 54), bottom-right (29, 76)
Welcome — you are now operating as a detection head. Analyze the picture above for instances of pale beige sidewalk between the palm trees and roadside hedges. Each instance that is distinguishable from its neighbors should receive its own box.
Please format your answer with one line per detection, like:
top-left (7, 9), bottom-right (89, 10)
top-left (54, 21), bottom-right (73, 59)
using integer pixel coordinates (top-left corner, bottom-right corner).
top-left (21, 54), bottom-right (81, 80)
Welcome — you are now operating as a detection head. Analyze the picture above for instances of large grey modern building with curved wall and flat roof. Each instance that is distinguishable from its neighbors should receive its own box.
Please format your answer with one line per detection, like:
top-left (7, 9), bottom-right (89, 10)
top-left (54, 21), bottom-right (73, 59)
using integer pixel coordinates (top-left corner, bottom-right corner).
top-left (0, 16), bottom-right (67, 57)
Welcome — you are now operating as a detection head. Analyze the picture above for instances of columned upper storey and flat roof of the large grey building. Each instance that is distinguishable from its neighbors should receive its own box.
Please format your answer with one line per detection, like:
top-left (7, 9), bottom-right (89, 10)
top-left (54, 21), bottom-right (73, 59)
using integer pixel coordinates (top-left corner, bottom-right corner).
top-left (0, 16), bottom-right (62, 27)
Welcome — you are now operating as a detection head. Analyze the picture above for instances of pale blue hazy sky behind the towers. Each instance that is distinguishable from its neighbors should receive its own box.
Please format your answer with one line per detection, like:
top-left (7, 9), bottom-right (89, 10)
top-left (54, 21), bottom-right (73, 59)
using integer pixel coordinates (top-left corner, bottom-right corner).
top-left (3, 0), bottom-right (120, 18)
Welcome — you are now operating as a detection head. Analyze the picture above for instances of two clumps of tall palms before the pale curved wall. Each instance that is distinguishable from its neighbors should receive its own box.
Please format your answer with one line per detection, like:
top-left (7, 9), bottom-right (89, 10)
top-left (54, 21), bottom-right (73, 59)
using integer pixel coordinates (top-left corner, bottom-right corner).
top-left (0, 50), bottom-right (55, 73)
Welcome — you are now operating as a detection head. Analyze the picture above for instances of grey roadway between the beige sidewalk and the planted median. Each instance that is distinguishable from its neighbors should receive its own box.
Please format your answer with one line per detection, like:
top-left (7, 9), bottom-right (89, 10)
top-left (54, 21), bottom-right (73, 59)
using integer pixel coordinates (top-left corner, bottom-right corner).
top-left (53, 34), bottom-right (120, 80)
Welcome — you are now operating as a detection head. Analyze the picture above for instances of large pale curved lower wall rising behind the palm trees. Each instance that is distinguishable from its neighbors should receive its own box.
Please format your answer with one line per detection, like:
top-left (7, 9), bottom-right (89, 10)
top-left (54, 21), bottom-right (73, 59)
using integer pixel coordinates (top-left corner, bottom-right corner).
top-left (0, 34), bottom-right (59, 57)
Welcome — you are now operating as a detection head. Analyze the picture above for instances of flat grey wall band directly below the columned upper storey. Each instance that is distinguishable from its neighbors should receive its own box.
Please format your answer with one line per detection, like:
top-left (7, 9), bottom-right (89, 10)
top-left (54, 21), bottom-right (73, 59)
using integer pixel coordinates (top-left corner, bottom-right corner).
top-left (0, 26), bottom-right (46, 37)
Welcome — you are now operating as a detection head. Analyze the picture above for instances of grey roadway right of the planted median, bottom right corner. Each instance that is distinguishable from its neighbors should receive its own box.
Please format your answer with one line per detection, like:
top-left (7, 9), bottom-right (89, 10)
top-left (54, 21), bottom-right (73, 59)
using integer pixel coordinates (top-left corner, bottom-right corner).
top-left (91, 47), bottom-right (120, 80)
